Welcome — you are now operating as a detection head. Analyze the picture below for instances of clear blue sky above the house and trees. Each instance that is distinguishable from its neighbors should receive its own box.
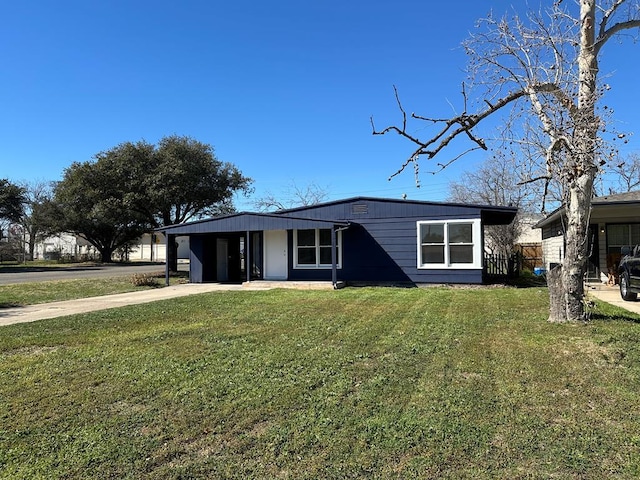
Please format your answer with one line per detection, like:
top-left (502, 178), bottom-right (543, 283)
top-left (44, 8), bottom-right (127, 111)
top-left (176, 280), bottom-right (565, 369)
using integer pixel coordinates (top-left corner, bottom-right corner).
top-left (0, 0), bottom-right (640, 210)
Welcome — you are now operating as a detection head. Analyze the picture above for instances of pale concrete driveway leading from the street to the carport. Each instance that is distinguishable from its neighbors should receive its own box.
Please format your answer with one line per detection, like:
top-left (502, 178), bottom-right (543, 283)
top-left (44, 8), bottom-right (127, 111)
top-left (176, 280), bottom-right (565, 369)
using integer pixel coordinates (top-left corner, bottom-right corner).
top-left (0, 283), bottom-right (252, 326)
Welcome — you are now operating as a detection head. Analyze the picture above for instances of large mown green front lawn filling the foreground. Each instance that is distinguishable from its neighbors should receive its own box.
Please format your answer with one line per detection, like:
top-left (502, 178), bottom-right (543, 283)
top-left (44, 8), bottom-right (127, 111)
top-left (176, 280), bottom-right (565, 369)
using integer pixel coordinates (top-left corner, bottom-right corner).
top-left (0, 288), bottom-right (640, 479)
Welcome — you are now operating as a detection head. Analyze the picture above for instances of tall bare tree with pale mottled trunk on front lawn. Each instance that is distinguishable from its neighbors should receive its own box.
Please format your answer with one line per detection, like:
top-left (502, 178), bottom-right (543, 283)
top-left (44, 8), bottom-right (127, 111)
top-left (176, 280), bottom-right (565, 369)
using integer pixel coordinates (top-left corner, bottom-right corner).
top-left (372, 0), bottom-right (640, 321)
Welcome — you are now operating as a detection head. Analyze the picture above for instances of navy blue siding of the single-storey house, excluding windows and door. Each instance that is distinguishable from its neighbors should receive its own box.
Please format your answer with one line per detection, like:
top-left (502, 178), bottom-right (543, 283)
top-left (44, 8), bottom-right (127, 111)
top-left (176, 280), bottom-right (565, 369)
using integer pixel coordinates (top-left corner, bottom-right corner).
top-left (161, 197), bottom-right (516, 284)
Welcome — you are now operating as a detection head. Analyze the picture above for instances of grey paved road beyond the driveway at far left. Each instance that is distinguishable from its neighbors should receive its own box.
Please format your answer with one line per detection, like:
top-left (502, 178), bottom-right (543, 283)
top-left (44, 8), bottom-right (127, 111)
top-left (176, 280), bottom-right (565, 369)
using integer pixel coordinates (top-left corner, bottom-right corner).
top-left (0, 262), bottom-right (189, 285)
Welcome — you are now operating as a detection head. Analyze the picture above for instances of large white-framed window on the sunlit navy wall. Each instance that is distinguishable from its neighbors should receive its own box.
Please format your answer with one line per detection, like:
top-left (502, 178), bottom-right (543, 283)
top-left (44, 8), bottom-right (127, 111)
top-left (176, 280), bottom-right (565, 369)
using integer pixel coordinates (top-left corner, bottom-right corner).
top-left (417, 219), bottom-right (482, 268)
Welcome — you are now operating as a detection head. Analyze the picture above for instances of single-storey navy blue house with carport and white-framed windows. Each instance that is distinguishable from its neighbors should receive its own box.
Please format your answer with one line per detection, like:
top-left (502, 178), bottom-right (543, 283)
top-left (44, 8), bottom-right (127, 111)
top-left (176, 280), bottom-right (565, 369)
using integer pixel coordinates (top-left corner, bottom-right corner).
top-left (159, 197), bottom-right (517, 286)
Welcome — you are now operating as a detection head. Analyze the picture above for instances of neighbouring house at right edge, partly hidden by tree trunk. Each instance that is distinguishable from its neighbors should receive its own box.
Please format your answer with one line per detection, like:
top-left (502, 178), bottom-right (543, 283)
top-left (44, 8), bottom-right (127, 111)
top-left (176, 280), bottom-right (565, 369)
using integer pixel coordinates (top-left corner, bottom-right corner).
top-left (535, 191), bottom-right (640, 282)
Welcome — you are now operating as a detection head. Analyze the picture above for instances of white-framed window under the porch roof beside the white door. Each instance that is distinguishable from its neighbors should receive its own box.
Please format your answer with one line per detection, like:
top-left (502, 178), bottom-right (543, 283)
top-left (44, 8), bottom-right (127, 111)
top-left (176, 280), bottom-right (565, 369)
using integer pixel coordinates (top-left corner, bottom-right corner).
top-left (293, 228), bottom-right (342, 268)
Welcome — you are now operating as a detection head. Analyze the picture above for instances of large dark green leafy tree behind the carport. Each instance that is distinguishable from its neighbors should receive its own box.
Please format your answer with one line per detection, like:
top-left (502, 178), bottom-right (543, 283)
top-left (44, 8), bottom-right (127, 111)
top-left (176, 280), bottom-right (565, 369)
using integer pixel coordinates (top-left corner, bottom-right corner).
top-left (52, 135), bottom-right (252, 262)
